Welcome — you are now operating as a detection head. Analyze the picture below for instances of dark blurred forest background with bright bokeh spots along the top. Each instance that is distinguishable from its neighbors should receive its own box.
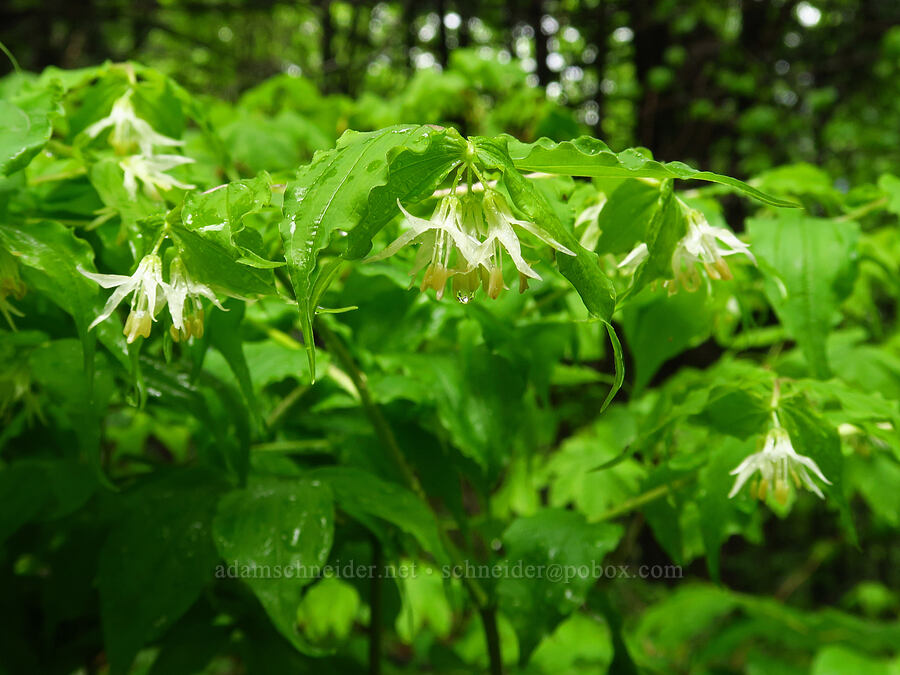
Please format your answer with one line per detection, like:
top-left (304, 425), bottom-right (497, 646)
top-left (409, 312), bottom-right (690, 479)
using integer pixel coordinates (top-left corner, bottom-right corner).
top-left (0, 0), bottom-right (900, 187)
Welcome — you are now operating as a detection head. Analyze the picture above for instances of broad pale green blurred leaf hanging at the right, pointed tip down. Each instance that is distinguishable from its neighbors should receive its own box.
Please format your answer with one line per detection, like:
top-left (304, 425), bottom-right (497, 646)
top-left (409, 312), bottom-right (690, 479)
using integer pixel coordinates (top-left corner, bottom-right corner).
top-left (748, 212), bottom-right (859, 379)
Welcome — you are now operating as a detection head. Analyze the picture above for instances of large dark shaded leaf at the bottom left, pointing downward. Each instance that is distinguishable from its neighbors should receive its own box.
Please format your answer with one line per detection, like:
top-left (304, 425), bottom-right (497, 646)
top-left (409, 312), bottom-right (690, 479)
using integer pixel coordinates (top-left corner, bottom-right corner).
top-left (99, 469), bottom-right (224, 675)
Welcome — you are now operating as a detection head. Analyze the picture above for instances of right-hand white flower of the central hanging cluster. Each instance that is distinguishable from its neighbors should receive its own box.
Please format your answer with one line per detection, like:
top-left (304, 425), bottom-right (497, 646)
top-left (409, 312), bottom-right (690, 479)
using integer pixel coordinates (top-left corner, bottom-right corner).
top-left (478, 189), bottom-right (575, 298)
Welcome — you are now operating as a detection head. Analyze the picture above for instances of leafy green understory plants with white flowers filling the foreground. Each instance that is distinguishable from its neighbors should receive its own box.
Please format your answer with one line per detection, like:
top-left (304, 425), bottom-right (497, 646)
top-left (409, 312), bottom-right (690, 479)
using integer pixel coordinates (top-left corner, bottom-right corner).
top-left (0, 63), bottom-right (900, 674)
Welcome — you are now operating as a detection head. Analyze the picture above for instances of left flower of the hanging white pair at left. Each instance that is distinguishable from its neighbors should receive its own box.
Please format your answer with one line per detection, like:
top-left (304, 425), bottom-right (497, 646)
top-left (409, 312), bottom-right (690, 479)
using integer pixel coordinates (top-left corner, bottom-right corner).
top-left (78, 253), bottom-right (166, 344)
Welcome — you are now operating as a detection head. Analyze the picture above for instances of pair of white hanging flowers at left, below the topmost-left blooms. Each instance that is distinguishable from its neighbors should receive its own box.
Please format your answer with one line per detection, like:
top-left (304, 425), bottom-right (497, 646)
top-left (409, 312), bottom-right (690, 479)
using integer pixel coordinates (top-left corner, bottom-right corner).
top-left (78, 253), bottom-right (225, 344)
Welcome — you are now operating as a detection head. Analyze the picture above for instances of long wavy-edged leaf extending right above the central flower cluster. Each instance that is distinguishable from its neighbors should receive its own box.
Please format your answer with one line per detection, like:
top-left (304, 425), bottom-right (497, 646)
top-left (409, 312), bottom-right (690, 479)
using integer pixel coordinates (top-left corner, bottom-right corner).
top-left (508, 136), bottom-right (796, 206)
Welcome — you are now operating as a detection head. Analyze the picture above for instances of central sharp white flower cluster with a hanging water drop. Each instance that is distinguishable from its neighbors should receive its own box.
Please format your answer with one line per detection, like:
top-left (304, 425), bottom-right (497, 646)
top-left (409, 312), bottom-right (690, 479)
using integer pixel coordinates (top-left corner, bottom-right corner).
top-left (368, 188), bottom-right (575, 302)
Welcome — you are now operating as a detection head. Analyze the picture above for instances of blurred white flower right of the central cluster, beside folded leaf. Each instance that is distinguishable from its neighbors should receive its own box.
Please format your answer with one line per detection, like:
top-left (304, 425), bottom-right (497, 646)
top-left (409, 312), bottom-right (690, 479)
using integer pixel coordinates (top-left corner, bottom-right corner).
top-left (666, 209), bottom-right (756, 293)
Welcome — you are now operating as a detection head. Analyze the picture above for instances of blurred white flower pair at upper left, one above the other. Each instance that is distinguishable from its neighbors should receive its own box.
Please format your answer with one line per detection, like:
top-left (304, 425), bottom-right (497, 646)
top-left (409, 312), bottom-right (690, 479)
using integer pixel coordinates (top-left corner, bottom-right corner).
top-left (85, 89), bottom-right (194, 199)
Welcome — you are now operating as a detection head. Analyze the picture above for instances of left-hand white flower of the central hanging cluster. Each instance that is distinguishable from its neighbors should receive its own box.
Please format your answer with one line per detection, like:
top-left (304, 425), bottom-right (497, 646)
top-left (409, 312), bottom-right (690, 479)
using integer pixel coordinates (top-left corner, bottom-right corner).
top-left (366, 195), bottom-right (478, 299)
